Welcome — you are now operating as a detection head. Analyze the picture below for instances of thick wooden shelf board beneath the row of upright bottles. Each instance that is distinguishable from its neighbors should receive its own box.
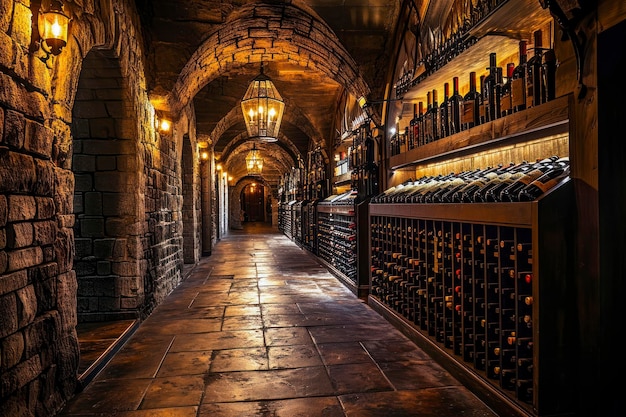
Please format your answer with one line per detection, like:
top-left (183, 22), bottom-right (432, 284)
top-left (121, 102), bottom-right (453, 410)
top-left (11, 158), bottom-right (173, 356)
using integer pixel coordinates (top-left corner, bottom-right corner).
top-left (388, 94), bottom-right (572, 169)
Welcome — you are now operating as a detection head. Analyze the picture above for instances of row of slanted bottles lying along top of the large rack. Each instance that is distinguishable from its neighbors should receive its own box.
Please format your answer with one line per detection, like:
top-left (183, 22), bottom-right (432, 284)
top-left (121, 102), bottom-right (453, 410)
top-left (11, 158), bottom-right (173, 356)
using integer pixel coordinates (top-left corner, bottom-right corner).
top-left (371, 156), bottom-right (570, 203)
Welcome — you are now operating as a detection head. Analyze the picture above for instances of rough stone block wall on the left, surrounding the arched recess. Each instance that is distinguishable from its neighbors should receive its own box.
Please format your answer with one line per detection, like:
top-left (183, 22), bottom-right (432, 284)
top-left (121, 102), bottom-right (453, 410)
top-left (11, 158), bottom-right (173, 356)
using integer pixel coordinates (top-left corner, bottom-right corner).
top-left (0, 0), bottom-right (201, 417)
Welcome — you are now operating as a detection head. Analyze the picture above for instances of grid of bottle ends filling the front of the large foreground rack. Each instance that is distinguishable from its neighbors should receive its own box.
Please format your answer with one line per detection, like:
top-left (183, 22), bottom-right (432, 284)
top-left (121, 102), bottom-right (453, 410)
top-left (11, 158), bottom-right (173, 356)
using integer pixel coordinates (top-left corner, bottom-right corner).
top-left (370, 216), bottom-right (534, 404)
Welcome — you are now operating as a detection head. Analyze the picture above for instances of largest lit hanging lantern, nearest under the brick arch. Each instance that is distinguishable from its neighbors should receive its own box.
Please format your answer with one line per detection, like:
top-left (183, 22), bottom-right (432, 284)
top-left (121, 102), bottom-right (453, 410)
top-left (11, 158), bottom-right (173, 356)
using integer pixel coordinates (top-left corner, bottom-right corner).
top-left (241, 65), bottom-right (285, 142)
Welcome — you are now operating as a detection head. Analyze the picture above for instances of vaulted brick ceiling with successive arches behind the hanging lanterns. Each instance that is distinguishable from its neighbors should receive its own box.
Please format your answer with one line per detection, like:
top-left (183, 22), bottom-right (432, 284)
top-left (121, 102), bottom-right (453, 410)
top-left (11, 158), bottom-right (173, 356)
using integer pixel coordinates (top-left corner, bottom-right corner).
top-left (136, 0), bottom-right (400, 185)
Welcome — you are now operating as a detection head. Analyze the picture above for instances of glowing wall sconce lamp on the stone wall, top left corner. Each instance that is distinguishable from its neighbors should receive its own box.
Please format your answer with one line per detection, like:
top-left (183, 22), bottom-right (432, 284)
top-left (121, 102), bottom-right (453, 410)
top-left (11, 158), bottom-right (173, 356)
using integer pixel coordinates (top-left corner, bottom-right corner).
top-left (32, 0), bottom-right (71, 64)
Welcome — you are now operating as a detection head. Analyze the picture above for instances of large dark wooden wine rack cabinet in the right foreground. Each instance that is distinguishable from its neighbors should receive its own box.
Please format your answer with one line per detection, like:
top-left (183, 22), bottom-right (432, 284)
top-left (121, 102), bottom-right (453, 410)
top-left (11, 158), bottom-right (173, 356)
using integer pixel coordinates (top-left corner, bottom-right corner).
top-left (368, 179), bottom-right (573, 415)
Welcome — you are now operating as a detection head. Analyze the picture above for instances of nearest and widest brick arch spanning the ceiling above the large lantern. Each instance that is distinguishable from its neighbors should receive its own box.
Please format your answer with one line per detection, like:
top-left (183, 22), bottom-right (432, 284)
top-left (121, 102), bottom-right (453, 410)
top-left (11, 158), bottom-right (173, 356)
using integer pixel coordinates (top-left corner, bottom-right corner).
top-left (154, 3), bottom-right (370, 115)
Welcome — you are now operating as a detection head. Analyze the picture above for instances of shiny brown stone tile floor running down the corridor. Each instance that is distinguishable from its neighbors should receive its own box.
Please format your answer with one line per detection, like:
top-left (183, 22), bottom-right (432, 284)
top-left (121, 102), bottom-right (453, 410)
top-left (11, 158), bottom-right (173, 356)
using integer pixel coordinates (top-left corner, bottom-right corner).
top-left (61, 223), bottom-right (497, 417)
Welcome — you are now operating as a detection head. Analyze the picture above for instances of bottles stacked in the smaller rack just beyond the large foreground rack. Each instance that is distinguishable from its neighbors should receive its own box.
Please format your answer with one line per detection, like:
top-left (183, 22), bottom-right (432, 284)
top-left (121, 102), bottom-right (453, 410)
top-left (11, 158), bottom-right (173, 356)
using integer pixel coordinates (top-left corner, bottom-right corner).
top-left (317, 211), bottom-right (357, 282)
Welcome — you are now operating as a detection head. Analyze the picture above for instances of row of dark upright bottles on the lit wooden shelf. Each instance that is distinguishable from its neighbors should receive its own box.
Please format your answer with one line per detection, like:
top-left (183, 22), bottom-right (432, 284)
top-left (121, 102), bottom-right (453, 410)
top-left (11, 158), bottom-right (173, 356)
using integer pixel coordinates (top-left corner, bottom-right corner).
top-left (390, 30), bottom-right (557, 155)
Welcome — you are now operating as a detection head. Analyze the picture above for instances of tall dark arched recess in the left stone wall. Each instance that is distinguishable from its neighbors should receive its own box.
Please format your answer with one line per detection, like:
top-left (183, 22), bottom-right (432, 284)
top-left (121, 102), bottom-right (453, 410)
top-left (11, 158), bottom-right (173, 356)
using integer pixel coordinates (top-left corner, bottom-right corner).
top-left (71, 49), bottom-right (144, 322)
